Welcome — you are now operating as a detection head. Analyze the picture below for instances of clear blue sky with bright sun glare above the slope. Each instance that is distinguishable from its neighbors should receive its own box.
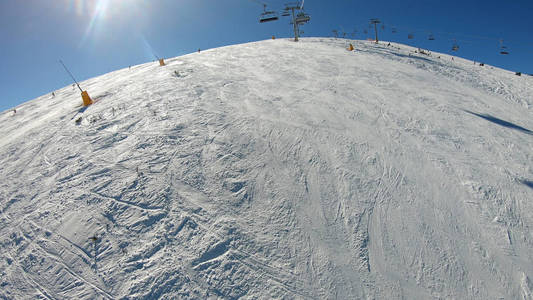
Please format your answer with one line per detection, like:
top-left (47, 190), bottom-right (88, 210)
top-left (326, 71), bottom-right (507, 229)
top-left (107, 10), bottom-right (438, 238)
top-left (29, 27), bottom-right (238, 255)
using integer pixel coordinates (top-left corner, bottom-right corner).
top-left (0, 0), bottom-right (533, 111)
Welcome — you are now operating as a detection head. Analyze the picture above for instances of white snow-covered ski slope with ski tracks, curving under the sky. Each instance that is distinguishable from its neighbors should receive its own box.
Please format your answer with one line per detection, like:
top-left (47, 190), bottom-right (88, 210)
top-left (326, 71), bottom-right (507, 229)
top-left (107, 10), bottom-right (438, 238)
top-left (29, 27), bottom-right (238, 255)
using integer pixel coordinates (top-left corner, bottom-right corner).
top-left (0, 38), bottom-right (533, 299)
